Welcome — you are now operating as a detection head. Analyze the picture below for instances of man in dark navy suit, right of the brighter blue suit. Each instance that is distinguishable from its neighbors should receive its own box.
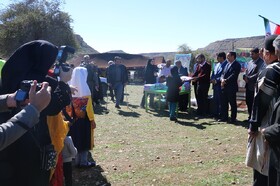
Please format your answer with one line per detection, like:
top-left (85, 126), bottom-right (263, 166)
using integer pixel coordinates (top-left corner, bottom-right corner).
top-left (218, 52), bottom-right (241, 123)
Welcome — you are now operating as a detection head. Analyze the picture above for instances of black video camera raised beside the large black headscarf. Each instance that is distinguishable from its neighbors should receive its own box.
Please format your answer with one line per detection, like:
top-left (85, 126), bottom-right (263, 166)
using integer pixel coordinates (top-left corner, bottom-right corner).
top-left (53, 46), bottom-right (75, 76)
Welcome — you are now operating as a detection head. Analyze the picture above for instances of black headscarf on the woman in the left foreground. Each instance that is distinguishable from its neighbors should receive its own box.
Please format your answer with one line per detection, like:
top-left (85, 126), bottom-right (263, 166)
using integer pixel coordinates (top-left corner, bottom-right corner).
top-left (1, 40), bottom-right (58, 94)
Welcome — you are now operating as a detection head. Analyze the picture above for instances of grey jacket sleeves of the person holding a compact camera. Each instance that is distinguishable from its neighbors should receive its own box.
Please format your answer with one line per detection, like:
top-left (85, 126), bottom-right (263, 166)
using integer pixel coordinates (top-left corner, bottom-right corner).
top-left (0, 95), bottom-right (40, 151)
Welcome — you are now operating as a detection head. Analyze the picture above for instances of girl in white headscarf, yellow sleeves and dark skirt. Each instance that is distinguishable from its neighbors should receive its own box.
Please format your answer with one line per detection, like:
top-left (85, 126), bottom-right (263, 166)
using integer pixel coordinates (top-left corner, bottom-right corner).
top-left (67, 67), bottom-right (96, 167)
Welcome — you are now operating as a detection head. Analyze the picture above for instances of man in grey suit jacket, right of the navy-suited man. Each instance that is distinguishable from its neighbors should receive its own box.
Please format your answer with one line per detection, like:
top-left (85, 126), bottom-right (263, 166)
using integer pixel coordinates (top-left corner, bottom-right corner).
top-left (243, 48), bottom-right (265, 121)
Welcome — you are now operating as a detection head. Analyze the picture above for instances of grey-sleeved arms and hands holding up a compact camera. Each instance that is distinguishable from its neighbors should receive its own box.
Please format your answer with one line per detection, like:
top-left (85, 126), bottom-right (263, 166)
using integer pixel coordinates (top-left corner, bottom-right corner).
top-left (0, 81), bottom-right (51, 151)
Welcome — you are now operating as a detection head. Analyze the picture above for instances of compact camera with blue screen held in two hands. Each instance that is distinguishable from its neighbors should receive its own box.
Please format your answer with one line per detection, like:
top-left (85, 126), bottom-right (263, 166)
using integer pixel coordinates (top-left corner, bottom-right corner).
top-left (15, 80), bottom-right (42, 102)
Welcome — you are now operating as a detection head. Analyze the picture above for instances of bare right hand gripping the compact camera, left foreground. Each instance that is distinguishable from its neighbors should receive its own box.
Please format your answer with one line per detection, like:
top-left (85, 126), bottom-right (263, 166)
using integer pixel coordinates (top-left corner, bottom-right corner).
top-left (29, 80), bottom-right (51, 112)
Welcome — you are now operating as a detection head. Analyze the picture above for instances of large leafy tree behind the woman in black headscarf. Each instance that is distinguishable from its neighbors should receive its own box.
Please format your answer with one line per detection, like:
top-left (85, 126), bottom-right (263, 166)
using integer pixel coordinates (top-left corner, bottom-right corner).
top-left (0, 0), bottom-right (77, 56)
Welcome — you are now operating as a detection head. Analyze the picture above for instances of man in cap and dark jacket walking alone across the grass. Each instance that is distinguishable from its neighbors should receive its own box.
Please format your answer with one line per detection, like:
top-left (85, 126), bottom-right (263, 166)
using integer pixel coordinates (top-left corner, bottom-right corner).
top-left (107, 56), bottom-right (128, 109)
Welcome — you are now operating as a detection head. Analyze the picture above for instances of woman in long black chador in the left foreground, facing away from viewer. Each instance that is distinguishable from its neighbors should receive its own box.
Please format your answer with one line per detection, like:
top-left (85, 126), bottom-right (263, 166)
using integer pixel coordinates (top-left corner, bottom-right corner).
top-left (0, 40), bottom-right (72, 186)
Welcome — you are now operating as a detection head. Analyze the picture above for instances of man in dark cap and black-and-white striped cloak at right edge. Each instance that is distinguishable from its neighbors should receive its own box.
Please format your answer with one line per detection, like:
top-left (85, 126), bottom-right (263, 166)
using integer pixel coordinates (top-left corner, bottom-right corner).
top-left (248, 35), bottom-right (280, 185)
